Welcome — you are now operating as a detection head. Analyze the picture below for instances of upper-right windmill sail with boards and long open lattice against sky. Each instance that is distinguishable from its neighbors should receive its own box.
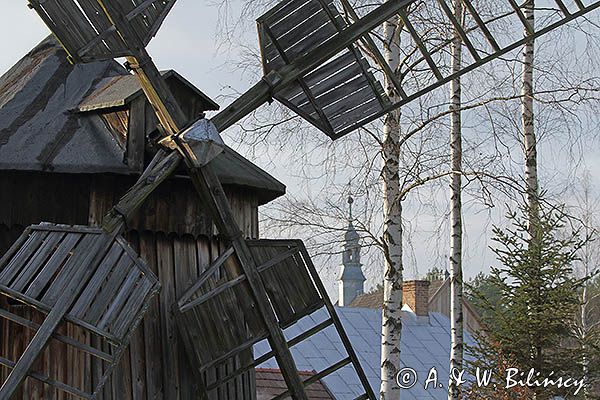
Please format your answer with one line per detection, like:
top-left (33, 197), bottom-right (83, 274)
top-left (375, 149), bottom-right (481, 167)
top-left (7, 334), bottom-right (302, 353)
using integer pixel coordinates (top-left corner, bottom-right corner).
top-left (213, 0), bottom-right (600, 139)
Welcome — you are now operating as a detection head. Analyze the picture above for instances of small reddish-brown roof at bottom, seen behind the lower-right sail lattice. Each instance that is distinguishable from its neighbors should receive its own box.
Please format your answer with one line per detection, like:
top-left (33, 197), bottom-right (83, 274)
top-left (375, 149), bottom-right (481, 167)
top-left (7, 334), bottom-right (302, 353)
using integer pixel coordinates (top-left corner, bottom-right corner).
top-left (256, 368), bottom-right (335, 400)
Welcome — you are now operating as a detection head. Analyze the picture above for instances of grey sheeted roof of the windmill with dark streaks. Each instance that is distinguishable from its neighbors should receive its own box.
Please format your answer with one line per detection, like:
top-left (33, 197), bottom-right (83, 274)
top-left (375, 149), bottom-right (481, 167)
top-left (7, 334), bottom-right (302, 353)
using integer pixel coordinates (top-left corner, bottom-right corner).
top-left (0, 37), bottom-right (285, 203)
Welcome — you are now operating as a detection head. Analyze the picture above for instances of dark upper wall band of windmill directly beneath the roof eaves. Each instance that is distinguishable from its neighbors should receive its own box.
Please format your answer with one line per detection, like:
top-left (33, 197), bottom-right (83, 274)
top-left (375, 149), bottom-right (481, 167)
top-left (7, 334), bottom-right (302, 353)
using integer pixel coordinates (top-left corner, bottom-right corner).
top-left (0, 172), bottom-right (259, 254)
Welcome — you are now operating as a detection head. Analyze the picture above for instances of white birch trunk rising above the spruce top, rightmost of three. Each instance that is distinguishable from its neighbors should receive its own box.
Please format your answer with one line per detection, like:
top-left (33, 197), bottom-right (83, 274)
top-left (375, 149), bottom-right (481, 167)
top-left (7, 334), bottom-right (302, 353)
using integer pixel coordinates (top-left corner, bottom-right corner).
top-left (521, 0), bottom-right (539, 237)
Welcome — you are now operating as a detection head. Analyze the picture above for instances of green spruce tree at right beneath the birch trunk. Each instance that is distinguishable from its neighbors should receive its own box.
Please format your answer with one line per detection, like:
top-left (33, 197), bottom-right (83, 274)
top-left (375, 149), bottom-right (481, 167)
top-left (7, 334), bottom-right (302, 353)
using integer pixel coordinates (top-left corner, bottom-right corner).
top-left (469, 203), bottom-right (587, 400)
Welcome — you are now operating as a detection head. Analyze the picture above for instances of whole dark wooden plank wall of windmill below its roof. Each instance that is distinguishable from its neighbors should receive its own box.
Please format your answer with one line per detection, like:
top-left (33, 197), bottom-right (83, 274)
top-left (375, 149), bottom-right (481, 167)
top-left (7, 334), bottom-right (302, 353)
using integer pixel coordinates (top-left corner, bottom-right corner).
top-left (0, 171), bottom-right (258, 400)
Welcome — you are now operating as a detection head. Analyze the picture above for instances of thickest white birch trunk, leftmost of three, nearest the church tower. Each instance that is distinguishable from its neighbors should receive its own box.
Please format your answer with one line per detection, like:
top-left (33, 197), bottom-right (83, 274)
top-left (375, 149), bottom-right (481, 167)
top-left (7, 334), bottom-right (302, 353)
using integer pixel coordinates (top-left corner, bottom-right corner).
top-left (380, 10), bottom-right (402, 400)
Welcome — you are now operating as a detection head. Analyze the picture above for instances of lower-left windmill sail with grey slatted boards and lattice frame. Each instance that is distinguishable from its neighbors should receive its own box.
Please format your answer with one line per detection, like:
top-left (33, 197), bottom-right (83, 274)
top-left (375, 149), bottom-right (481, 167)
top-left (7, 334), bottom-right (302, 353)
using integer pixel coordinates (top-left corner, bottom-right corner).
top-left (0, 224), bottom-right (160, 399)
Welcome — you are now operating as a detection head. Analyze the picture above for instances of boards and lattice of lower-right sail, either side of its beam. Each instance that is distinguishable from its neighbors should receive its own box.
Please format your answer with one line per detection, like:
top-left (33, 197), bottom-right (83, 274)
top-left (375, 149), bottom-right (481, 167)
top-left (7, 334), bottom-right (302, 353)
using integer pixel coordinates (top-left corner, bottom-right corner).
top-left (177, 239), bottom-right (374, 399)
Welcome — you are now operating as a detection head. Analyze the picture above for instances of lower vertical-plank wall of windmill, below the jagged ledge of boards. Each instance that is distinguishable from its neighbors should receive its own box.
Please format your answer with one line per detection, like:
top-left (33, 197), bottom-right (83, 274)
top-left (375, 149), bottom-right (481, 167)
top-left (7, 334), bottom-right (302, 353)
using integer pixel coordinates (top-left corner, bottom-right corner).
top-left (0, 231), bottom-right (254, 400)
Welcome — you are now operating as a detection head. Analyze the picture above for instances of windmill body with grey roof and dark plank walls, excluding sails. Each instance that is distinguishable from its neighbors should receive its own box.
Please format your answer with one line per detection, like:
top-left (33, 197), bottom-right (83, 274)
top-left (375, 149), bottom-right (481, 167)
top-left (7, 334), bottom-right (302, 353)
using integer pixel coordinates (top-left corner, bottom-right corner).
top-left (0, 37), bottom-right (285, 400)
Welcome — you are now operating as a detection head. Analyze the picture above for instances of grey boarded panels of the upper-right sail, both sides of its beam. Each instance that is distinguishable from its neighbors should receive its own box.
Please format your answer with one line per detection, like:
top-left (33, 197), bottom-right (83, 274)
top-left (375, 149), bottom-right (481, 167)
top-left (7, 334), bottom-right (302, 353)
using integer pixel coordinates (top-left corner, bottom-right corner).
top-left (258, 0), bottom-right (389, 137)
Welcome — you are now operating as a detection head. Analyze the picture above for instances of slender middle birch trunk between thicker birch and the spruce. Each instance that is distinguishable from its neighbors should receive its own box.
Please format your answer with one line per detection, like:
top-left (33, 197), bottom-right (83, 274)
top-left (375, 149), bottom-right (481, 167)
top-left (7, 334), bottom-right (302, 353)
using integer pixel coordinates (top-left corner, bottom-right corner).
top-left (448, 0), bottom-right (463, 399)
